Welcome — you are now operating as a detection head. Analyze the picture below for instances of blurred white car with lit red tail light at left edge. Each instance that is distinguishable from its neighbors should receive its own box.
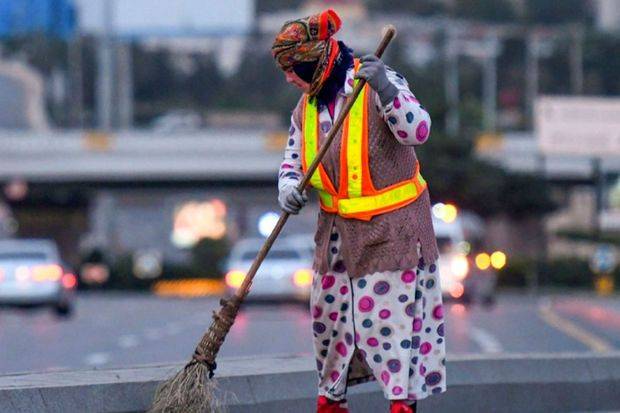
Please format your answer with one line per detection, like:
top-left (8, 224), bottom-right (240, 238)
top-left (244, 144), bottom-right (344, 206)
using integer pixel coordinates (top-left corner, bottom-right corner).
top-left (0, 239), bottom-right (77, 316)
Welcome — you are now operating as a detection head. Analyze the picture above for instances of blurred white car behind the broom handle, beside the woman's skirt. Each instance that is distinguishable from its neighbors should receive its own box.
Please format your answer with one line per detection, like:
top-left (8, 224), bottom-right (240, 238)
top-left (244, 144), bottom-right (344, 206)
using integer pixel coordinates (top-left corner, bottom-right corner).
top-left (225, 236), bottom-right (314, 302)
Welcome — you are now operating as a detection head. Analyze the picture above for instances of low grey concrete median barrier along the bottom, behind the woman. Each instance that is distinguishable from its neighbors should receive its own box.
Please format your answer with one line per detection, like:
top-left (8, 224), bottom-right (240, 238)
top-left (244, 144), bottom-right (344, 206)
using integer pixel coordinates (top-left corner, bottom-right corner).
top-left (0, 352), bottom-right (620, 413)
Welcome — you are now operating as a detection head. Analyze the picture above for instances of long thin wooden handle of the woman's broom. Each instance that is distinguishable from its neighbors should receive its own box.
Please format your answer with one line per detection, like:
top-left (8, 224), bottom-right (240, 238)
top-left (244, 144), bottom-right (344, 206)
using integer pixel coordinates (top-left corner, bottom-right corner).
top-left (235, 25), bottom-right (396, 300)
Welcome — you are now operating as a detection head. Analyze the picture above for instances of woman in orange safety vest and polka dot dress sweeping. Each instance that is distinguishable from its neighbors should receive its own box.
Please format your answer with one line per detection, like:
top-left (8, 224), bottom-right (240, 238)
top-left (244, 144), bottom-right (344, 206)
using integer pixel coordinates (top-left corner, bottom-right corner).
top-left (272, 10), bottom-right (446, 413)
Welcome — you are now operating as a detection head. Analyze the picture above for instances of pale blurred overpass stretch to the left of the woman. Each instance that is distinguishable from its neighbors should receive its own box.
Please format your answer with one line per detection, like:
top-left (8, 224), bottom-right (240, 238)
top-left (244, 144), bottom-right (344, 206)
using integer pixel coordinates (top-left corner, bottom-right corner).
top-left (0, 129), bottom-right (286, 183)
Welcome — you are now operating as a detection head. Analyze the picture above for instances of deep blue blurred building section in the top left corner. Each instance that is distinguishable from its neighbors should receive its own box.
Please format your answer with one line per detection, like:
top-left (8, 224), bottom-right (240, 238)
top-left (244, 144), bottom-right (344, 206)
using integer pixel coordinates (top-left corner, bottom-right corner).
top-left (0, 0), bottom-right (76, 38)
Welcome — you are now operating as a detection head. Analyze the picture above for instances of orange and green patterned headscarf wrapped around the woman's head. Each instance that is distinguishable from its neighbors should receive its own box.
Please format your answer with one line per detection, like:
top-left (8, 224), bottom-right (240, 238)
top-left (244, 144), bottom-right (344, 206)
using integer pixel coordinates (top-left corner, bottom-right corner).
top-left (271, 9), bottom-right (342, 96)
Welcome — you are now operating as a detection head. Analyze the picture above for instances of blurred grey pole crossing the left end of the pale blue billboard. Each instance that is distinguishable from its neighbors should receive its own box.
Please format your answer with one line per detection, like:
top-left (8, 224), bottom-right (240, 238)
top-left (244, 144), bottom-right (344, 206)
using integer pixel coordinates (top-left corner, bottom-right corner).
top-left (97, 0), bottom-right (115, 131)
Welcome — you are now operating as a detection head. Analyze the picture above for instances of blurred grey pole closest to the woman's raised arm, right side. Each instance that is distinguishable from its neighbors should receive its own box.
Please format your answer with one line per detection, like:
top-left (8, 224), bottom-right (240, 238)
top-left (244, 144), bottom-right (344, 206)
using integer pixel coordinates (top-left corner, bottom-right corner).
top-left (444, 28), bottom-right (461, 136)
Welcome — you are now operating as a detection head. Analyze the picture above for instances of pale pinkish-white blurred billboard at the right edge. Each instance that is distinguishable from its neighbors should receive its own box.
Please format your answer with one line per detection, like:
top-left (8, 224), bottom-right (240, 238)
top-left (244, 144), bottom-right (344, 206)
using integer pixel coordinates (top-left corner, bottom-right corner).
top-left (534, 96), bottom-right (620, 158)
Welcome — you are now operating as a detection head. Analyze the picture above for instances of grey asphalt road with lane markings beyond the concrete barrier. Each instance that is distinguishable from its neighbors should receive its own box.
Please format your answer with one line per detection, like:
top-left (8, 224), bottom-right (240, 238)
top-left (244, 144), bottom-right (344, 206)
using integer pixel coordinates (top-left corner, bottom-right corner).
top-left (0, 294), bottom-right (620, 374)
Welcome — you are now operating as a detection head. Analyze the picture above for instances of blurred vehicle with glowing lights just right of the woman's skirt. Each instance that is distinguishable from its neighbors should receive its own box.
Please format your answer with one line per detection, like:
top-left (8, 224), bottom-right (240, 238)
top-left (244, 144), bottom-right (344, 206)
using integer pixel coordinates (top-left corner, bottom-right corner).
top-left (433, 204), bottom-right (506, 305)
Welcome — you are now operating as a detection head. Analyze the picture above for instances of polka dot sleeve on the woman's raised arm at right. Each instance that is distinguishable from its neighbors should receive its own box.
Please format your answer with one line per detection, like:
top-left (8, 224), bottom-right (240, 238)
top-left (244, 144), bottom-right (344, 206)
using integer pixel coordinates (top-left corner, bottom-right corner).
top-left (375, 68), bottom-right (431, 145)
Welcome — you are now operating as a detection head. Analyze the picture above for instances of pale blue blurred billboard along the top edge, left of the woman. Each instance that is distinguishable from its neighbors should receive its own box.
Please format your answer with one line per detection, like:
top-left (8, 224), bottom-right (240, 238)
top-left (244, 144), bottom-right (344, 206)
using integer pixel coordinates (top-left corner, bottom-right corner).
top-left (76, 0), bottom-right (255, 37)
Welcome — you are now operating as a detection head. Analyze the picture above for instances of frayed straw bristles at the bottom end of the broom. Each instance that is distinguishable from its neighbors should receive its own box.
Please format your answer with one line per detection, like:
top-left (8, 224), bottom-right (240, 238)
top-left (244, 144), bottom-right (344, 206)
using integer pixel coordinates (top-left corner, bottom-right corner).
top-left (149, 363), bottom-right (225, 413)
